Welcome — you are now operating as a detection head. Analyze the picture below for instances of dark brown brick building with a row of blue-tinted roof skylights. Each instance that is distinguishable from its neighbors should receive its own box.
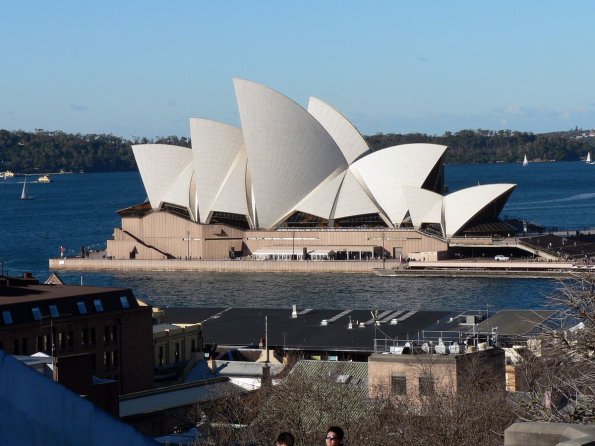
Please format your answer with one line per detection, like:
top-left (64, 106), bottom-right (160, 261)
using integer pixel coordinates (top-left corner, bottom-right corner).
top-left (0, 275), bottom-right (153, 394)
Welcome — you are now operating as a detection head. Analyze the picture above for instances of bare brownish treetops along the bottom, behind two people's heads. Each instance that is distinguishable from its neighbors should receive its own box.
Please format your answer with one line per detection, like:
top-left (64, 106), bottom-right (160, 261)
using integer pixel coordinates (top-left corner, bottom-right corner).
top-left (193, 363), bottom-right (514, 446)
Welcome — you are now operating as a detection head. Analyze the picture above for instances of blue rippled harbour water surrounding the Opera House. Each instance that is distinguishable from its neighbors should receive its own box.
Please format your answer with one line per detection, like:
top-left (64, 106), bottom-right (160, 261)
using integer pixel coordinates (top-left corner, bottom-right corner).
top-left (0, 162), bottom-right (595, 311)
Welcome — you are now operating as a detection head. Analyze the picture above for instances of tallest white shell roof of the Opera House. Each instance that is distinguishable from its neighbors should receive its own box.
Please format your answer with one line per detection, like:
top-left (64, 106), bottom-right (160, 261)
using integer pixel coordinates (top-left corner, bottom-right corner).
top-left (234, 79), bottom-right (347, 228)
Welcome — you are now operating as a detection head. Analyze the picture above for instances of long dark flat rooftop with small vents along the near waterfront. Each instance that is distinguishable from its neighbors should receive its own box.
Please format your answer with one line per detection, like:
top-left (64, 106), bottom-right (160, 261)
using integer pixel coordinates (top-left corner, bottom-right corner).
top-left (163, 307), bottom-right (554, 353)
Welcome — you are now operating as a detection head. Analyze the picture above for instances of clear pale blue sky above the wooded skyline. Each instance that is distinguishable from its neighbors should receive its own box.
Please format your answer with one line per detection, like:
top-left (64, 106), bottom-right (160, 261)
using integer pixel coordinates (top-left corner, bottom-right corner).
top-left (0, 0), bottom-right (595, 137)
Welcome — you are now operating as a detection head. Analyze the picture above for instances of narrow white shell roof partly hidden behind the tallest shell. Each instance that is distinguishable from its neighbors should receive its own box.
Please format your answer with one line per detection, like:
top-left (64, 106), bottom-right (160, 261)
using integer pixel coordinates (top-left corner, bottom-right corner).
top-left (308, 98), bottom-right (370, 164)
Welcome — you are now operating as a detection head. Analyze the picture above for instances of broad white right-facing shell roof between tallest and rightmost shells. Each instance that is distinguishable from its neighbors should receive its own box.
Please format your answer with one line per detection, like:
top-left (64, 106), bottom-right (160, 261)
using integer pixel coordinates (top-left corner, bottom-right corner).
top-left (350, 144), bottom-right (446, 226)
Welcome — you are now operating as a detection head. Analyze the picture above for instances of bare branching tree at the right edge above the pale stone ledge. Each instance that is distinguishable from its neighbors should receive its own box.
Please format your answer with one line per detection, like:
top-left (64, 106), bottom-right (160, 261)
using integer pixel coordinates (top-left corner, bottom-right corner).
top-left (517, 272), bottom-right (595, 423)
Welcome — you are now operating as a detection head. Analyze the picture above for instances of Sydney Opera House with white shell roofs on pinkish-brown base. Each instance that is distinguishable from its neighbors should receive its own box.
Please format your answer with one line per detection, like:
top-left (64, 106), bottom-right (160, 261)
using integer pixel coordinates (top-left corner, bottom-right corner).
top-left (107, 79), bottom-right (515, 260)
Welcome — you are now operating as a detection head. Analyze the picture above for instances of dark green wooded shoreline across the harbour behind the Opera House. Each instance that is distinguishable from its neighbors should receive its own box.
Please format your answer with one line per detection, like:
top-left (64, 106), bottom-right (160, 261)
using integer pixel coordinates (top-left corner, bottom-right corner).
top-left (0, 129), bottom-right (595, 173)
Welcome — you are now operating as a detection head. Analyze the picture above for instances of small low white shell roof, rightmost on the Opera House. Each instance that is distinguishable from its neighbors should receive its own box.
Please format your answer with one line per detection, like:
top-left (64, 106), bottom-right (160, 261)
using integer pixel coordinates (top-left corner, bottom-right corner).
top-left (444, 184), bottom-right (516, 237)
